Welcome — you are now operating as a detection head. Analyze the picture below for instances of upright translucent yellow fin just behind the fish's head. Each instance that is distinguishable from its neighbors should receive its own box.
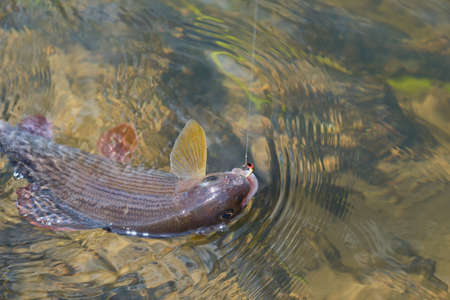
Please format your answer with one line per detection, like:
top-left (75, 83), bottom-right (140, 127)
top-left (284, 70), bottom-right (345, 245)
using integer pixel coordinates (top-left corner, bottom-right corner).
top-left (170, 120), bottom-right (207, 178)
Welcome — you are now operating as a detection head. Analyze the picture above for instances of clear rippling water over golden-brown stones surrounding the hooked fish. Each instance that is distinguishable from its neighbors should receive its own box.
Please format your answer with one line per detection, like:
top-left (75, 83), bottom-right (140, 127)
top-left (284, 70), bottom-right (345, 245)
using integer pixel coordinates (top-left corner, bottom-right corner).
top-left (0, 0), bottom-right (450, 299)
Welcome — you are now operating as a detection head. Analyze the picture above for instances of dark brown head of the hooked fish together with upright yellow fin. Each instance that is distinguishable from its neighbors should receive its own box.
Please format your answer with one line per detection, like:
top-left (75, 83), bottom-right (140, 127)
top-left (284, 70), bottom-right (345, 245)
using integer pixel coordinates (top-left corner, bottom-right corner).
top-left (170, 120), bottom-right (258, 228)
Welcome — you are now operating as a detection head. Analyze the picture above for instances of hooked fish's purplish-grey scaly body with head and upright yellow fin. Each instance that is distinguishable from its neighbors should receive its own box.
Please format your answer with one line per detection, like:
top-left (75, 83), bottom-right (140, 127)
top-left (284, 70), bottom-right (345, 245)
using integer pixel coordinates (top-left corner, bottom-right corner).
top-left (0, 120), bottom-right (258, 238)
